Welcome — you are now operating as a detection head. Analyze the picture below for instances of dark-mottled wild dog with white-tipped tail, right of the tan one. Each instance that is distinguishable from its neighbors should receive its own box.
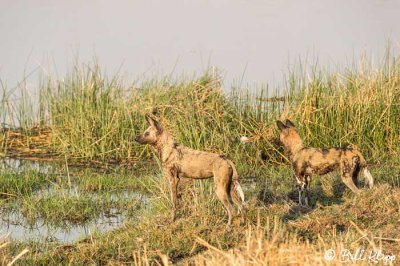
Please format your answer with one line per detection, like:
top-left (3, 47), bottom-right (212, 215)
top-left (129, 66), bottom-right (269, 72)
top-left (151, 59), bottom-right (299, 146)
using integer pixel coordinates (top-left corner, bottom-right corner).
top-left (276, 119), bottom-right (374, 205)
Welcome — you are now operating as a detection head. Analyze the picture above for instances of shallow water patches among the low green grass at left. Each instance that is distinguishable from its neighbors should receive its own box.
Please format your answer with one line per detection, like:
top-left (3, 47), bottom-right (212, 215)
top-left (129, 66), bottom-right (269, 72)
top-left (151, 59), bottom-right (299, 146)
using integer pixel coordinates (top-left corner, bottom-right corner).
top-left (0, 158), bottom-right (148, 243)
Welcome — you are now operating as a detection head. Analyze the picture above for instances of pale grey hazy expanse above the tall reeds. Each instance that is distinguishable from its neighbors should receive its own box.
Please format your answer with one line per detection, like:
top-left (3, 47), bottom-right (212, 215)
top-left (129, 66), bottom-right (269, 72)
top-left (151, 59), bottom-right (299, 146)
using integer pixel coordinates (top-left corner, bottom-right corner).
top-left (0, 0), bottom-right (400, 90)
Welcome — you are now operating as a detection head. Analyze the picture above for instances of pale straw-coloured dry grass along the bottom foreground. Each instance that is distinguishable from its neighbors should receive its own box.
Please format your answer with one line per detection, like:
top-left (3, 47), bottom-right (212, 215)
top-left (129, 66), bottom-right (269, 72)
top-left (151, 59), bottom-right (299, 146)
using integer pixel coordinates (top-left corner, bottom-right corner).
top-left (126, 220), bottom-right (397, 266)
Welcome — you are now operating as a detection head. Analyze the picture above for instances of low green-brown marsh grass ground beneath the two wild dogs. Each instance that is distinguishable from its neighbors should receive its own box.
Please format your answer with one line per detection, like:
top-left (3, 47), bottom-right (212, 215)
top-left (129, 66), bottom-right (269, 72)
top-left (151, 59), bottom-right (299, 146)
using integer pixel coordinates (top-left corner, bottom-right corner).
top-left (3, 160), bottom-right (400, 265)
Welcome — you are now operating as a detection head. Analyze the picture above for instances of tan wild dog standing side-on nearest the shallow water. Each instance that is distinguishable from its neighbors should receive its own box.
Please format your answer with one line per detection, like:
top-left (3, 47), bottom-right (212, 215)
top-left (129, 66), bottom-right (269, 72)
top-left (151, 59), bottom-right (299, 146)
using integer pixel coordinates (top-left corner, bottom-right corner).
top-left (135, 115), bottom-right (245, 225)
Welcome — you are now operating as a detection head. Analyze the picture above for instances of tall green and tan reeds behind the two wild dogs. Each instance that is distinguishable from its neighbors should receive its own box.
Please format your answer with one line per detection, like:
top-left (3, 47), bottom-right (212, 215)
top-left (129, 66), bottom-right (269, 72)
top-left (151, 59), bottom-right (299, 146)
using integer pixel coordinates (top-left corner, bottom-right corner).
top-left (0, 54), bottom-right (400, 165)
